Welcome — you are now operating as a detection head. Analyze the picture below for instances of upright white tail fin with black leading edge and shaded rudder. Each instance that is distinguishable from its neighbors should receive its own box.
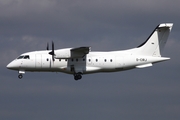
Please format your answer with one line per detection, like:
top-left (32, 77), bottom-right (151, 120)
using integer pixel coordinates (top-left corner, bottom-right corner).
top-left (138, 23), bottom-right (173, 57)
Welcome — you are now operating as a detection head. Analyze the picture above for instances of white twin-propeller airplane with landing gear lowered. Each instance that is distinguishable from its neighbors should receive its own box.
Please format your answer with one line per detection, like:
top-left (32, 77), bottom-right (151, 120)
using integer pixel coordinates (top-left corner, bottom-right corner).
top-left (7, 23), bottom-right (173, 80)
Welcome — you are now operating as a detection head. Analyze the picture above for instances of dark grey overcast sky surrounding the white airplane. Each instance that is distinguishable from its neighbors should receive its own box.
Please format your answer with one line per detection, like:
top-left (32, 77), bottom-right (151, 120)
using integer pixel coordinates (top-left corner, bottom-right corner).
top-left (0, 0), bottom-right (180, 120)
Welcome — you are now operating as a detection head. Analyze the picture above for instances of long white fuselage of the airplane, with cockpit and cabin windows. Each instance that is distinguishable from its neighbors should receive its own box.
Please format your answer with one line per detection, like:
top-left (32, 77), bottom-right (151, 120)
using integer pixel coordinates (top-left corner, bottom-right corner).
top-left (7, 50), bottom-right (168, 74)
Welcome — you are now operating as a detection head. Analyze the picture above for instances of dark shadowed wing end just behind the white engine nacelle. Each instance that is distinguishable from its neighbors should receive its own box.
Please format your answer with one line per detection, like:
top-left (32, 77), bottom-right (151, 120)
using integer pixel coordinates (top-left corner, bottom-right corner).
top-left (71, 47), bottom-right (91, 57)
